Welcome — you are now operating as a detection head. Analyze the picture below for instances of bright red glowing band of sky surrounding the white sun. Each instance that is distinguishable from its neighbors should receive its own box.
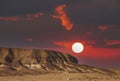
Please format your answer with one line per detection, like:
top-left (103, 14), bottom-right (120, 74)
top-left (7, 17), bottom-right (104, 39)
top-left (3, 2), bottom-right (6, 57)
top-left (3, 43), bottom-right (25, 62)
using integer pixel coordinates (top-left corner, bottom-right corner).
top-left (54, 41), bottom-right (120, 59)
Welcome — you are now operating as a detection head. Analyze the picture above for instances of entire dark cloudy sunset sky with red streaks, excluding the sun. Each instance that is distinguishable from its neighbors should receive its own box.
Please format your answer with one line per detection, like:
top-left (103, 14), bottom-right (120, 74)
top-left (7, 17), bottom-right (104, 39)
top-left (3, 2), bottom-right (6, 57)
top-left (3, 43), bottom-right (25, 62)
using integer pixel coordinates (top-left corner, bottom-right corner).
top-left (0, 0), bottom-right (120, 68)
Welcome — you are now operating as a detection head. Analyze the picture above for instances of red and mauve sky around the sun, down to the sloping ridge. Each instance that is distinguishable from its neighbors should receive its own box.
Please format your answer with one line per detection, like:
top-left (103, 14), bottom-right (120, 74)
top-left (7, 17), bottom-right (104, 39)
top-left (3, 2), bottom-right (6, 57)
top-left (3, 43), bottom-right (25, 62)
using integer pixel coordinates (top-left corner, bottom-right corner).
top-left (53, 41), bottom-right (120, 68)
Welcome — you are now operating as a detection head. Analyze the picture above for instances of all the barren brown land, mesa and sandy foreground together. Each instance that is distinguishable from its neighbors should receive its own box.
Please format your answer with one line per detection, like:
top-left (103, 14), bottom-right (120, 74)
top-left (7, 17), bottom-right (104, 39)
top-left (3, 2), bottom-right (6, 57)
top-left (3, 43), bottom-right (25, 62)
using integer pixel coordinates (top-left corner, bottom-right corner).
top-left (0, 48), bottom-right (120, 81)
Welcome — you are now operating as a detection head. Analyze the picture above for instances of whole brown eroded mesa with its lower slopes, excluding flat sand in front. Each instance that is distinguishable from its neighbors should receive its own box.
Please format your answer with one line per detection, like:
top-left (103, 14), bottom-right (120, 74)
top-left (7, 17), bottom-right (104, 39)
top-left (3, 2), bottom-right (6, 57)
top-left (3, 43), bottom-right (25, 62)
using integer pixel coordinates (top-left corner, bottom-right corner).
top-left (0, 48), bottom-right (117, 74)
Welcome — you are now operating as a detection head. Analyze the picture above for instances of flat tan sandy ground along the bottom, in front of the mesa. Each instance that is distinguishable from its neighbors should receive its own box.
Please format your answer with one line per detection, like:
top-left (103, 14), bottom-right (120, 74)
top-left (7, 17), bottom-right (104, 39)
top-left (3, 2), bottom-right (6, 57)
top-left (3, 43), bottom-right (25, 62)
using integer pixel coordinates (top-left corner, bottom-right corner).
top-left (0, 73), bottom-right (120, 81)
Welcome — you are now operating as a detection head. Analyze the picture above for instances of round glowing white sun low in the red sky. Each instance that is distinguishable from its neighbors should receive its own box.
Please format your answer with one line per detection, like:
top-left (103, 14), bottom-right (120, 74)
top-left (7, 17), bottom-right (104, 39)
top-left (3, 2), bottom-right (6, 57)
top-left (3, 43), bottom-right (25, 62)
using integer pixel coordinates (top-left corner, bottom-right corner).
top-left (72, 42), bottom-right (84, 53)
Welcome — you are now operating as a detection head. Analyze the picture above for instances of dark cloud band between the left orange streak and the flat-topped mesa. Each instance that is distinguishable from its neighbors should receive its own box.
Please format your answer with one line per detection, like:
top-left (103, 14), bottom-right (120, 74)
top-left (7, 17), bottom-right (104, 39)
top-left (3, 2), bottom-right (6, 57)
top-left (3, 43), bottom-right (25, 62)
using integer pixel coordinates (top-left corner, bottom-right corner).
top-left (0, 15), bottom-right (69, 47)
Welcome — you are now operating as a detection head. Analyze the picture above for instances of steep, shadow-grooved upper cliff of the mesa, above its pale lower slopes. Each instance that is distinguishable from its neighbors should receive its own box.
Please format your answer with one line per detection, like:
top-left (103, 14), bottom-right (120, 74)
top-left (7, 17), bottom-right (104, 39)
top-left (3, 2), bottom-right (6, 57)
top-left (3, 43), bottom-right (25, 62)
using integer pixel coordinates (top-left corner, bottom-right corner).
top-left (0, 48), bottom-right (78, 64)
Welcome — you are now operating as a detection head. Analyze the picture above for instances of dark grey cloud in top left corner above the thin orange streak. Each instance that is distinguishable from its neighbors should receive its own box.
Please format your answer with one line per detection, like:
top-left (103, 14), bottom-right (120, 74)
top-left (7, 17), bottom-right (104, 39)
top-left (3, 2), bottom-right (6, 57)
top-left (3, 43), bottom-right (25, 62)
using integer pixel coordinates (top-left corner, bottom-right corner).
top-left (0, 0), bottom-right (69, 16)
